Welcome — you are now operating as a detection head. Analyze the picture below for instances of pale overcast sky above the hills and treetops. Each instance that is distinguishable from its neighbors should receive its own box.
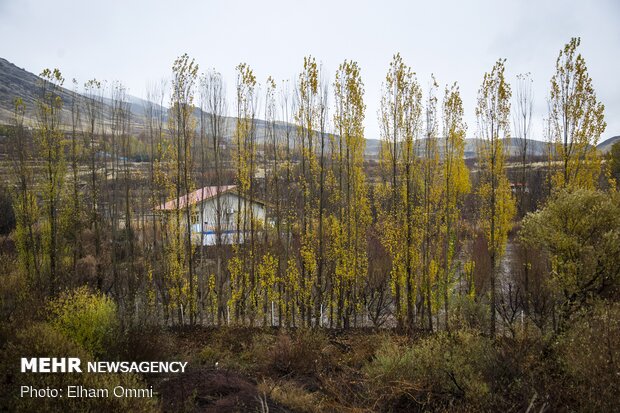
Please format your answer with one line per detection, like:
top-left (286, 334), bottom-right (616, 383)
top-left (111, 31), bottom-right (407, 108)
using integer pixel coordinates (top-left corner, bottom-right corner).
top-left (0, 0), bottom-right (620, 141)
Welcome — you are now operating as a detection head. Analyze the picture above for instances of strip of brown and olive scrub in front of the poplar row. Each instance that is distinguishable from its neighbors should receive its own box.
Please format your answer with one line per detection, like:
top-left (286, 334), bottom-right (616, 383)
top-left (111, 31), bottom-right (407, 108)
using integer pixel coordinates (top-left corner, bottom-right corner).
top-left (2, 312), bottom-right (620, 412)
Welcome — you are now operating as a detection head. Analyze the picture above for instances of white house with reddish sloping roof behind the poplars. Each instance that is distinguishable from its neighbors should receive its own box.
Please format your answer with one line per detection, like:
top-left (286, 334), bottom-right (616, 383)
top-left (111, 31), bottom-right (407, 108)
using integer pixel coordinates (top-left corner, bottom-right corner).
top-left (156, 185), bottom-right (267, 245)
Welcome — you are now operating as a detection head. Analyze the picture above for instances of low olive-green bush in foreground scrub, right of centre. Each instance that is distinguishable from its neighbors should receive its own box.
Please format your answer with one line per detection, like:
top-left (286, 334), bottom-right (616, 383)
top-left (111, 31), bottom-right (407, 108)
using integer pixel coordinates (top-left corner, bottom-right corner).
top-left (365, 330), bottom-right (494, 410)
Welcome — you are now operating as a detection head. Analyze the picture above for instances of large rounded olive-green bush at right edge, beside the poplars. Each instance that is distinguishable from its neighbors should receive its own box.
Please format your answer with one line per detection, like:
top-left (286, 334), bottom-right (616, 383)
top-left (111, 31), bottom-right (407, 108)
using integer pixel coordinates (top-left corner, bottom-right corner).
top-left (519, 189), bottom-right (620, 330)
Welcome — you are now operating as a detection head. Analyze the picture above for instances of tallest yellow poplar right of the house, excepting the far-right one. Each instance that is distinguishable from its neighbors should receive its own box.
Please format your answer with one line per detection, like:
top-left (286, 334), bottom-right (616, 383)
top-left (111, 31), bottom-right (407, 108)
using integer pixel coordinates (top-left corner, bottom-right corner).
top-left (379, 54), bottom-right (422, 329)
